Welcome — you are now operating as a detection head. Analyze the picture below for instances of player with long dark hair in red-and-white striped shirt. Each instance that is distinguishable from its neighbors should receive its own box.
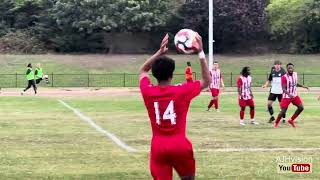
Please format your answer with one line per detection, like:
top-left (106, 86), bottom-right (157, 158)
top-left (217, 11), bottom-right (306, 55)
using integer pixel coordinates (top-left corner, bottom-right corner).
top-left (237, 67), bottom-right (258, 126)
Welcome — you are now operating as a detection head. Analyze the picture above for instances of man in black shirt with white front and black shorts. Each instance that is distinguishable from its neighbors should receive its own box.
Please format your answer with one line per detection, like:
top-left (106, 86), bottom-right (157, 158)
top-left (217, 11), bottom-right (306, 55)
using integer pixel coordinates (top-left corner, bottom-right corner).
top-left (262, 60), bottom-right (286, 123)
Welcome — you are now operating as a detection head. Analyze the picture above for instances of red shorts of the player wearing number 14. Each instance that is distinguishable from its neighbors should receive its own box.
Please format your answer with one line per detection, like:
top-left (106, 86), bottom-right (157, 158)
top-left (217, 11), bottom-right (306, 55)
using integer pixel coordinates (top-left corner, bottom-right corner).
top-left (150, 137), bottom-right (195, 180)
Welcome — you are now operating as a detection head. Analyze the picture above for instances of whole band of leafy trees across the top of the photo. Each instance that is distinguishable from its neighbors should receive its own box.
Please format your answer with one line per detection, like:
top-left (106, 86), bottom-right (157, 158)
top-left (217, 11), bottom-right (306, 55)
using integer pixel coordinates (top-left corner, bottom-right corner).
top-left (0, 0), bottom-right (320, 53)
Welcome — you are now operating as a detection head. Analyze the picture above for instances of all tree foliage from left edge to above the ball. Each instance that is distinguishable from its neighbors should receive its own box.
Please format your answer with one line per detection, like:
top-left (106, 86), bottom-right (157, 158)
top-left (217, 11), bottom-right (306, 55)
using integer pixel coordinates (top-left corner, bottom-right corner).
top-left (0, 0), bottom-right (173, 52)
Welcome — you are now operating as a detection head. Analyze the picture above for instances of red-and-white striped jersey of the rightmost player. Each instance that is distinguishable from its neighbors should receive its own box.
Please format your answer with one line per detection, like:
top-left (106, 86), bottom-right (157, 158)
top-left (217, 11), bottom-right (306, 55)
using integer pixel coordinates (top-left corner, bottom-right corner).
top-left (281, 72), bottom-right (298, 98)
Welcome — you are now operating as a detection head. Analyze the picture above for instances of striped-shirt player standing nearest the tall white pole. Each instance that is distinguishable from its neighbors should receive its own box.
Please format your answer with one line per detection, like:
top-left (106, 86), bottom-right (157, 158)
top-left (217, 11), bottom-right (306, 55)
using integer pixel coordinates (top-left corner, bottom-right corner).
top-left (207, 61), bottom-right (224, 112)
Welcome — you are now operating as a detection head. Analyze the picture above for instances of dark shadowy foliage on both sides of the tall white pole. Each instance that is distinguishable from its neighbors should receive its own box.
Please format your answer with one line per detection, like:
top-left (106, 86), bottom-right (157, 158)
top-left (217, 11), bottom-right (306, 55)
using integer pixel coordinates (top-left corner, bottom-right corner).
top-left (172, 0), bottom-right (267, 51)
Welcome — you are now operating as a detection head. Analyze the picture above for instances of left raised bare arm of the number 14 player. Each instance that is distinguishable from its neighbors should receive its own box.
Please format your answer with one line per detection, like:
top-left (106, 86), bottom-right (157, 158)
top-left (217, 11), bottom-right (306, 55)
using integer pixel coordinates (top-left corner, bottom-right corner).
top-left (139, 34), bottom-right (169, 77)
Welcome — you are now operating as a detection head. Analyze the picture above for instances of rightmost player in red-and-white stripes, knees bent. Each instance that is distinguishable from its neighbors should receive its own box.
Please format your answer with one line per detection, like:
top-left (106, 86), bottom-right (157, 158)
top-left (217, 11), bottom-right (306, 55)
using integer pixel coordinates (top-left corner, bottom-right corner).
top-left (273, 63), bottom-right (309, 128)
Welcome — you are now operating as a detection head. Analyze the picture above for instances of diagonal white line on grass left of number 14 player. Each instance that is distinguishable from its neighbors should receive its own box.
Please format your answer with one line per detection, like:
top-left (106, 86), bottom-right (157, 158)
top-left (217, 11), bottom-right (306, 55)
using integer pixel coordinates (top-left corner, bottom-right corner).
top-left (58, 100), bottom-right (137, 152)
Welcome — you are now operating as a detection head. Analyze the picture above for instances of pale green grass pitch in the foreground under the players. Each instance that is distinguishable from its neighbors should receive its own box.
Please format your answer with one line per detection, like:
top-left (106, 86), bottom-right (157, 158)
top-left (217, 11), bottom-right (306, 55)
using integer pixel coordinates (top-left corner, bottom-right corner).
top-left (0, 93), bottom-right (320, 179)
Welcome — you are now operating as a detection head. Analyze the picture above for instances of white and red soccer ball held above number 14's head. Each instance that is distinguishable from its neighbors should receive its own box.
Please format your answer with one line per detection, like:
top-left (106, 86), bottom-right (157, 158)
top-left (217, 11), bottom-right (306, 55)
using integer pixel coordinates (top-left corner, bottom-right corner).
top-left (174, 29), bottom-right (198, 54)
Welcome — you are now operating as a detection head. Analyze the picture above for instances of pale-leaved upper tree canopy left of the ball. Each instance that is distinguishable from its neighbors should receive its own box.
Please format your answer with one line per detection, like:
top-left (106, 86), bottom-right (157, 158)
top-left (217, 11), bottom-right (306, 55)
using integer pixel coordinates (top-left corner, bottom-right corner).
top-left (50, 0), bottom-right (170, 33)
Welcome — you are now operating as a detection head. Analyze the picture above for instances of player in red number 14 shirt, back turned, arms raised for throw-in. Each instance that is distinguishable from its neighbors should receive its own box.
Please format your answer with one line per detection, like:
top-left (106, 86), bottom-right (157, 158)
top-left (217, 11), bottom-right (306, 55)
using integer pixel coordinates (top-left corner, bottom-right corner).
top-left (140, 35), bottom-right (210, 180)
